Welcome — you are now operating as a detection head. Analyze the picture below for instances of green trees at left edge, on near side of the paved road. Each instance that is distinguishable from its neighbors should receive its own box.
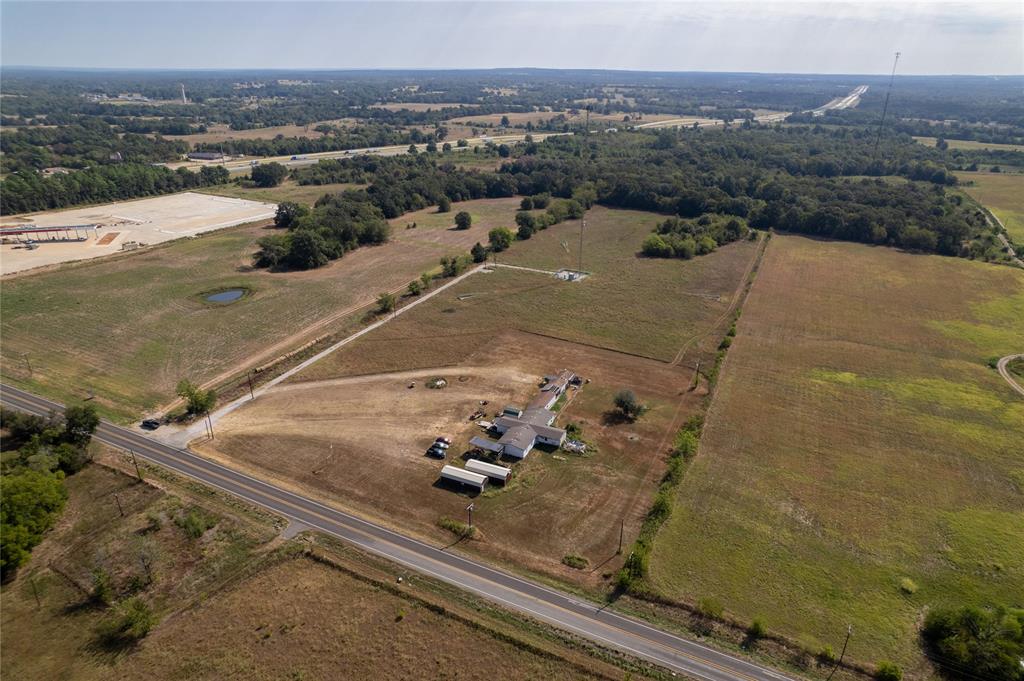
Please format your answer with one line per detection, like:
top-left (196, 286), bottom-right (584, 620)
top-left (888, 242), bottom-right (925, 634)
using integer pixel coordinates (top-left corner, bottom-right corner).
top-left (0, 405), bottom-right (99, 581)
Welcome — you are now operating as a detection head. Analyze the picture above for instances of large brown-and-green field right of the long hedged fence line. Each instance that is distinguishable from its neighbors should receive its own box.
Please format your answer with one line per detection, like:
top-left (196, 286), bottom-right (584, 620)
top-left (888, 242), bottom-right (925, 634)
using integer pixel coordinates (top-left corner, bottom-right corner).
top-left (650, 237), bottom-right (1024, 668)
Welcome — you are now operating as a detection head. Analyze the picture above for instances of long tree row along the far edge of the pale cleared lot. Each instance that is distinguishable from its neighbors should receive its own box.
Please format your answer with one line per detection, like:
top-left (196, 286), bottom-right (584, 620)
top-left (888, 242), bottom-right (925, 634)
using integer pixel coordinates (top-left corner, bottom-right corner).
top-left (0, 163), bottom-right (229, 215)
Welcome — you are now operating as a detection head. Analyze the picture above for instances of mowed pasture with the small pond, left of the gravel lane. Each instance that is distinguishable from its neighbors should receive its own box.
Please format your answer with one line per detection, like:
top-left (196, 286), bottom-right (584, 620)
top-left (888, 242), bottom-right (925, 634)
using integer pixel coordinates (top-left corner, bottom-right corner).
top-left (0, 199), bottom-right (518, 421)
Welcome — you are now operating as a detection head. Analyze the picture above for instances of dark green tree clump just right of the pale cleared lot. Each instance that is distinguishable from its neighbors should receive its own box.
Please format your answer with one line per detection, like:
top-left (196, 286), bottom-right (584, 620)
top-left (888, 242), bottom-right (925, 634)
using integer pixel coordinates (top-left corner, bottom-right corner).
top-left (254, 191), bottom-right (390, 269)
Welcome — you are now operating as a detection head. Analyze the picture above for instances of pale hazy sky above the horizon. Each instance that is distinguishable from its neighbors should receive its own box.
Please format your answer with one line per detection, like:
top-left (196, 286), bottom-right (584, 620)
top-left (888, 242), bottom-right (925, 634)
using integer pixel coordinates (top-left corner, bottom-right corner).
top-left (0, 0), bottom-right (1024, 75)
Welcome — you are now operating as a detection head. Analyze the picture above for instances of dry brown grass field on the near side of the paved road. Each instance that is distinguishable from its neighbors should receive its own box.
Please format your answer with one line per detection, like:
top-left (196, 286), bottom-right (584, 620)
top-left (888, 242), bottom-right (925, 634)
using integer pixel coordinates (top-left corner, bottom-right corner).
top-left (0, 456), bottom-right (645, 681)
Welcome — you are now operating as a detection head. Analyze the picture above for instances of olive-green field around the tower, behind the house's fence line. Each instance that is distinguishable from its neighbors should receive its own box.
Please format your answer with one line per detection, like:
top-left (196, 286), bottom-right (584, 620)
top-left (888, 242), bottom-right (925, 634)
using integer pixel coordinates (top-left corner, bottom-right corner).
top-left (302, 208), bottom-right (757, 380)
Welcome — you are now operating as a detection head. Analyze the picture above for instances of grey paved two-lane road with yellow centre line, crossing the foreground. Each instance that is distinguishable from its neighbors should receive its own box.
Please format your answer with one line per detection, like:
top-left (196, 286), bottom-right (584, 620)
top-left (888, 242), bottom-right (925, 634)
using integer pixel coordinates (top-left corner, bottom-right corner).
top-left (0, 386), bottom-right (786, 681)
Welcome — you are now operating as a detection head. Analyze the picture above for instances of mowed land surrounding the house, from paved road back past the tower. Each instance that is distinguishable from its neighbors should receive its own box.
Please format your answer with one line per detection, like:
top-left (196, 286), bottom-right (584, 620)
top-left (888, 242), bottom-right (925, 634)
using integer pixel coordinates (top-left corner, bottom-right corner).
top-left (194, 208), bottom-right (757, 587)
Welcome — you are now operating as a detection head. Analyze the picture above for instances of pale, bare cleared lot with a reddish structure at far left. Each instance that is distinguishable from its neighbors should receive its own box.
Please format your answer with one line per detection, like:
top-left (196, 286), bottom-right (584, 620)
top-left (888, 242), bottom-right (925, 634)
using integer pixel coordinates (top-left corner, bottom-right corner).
top-left (0, 191), bottom-right (276, 274)
